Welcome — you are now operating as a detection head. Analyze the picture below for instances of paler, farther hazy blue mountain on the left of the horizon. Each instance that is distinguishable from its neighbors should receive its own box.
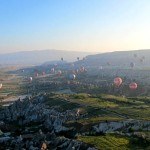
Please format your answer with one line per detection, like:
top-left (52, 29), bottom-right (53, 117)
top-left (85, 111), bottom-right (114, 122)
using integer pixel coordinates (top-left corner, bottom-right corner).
top-left (0, 50), bottom-right (90, 65)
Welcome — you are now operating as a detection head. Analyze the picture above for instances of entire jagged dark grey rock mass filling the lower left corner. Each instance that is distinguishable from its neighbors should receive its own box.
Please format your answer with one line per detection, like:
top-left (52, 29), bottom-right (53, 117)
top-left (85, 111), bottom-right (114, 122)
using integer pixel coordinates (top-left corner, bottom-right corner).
top-left (0, 95), bottom-right (94, 150)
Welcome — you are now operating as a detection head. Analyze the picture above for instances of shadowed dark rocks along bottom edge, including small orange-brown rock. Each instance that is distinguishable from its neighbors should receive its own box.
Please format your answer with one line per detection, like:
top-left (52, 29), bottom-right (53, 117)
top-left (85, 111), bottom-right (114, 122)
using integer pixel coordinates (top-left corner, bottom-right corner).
top-left (1, 133), bottom-right (96, 150)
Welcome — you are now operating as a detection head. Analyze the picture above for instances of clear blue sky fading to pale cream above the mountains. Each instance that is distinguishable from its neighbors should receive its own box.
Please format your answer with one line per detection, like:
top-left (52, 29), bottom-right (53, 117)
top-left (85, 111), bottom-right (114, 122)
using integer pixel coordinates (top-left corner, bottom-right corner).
top-left (0, 0), bottom-right (150, 53)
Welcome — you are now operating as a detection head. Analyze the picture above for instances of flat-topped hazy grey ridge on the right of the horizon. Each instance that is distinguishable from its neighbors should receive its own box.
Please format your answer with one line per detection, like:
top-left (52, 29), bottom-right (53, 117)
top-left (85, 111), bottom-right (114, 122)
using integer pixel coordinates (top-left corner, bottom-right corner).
top-left (81, 49), bottom-right (150, 67)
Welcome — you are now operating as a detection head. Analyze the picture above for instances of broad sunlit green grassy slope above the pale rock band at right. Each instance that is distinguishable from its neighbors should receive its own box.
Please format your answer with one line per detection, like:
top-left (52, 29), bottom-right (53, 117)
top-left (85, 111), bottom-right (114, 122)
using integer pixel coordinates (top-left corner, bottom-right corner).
top-left (44, 93), bottom-right (150, 123)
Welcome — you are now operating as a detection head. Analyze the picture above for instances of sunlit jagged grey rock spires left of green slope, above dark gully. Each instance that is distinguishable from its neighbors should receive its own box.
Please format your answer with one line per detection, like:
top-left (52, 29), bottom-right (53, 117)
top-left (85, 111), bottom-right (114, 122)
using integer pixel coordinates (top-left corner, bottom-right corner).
top-left (0, 96), bottom-right (75, 132)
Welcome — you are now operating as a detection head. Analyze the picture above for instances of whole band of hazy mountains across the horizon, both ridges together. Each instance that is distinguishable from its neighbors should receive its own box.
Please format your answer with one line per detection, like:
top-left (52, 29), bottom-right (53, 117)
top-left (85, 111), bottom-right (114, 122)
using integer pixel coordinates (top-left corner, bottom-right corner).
top-left (0, 49), bottom-right (150, 67)
